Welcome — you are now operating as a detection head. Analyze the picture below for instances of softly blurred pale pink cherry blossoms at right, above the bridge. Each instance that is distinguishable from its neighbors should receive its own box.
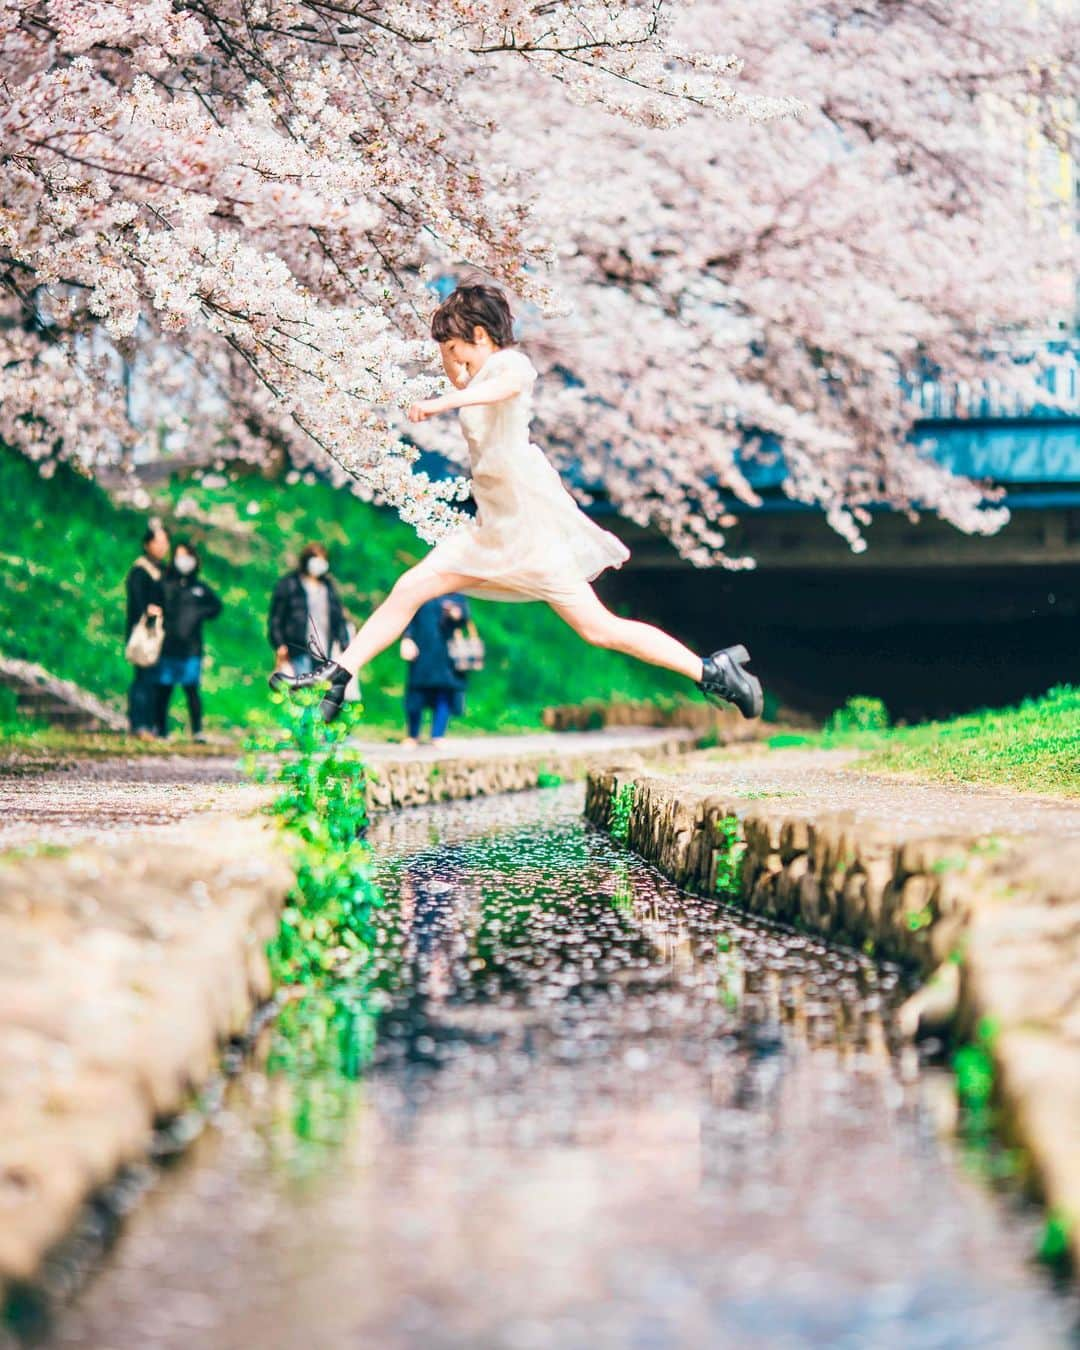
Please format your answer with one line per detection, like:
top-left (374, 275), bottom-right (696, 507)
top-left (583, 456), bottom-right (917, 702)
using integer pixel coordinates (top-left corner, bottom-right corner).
top-left (502, 0), bottom-right (1080, 566)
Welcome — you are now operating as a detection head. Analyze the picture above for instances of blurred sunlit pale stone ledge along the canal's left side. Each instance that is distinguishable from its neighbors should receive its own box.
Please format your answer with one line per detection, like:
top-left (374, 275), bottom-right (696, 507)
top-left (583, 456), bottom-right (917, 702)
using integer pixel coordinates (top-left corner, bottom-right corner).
top-left (0, 818), bottom-right (292, 1303)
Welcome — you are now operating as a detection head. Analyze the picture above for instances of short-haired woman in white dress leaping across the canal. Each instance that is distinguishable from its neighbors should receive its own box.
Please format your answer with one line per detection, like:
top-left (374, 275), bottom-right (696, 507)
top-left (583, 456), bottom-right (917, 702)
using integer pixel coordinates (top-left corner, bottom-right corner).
top-left (270, 285), bottom-right (761, 721)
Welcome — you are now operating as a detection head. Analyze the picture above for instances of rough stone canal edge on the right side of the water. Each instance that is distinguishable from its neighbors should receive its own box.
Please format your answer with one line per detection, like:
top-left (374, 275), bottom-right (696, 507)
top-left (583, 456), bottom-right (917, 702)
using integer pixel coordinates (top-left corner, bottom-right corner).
top-left (586, 765), bottom-right (1080, 1261)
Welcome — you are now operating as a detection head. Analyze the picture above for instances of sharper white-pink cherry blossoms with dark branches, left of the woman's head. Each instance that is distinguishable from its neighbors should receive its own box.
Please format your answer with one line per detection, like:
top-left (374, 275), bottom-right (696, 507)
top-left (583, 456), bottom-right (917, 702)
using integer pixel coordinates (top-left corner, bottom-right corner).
top-left (0, 0), bottom-right (788, 536)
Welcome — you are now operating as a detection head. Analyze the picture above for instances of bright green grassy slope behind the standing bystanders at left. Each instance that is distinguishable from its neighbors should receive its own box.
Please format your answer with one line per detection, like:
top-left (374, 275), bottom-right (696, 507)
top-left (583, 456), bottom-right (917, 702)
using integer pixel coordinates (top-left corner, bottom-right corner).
top-left (0, 448), bottom-right (687, 730)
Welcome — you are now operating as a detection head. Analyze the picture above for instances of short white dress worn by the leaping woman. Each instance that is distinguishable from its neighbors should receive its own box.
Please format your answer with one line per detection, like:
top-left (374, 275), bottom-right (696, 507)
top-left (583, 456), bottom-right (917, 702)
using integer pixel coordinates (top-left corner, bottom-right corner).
top-left (420, 347), bottom-right (630, 602)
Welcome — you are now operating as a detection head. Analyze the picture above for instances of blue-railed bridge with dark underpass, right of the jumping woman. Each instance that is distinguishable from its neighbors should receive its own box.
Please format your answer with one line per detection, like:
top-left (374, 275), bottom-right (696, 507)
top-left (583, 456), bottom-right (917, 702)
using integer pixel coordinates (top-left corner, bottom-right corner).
top-left (602, 386), bottom-right (1080, 718)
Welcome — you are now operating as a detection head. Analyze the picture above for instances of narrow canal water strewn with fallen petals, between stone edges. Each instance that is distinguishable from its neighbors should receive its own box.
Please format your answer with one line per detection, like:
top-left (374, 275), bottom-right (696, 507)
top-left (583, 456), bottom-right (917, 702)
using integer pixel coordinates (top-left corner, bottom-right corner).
top-left (50, 788), bottom-right (1072, 1350)
